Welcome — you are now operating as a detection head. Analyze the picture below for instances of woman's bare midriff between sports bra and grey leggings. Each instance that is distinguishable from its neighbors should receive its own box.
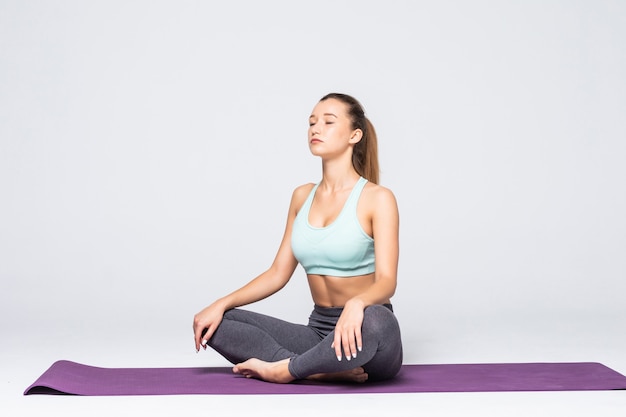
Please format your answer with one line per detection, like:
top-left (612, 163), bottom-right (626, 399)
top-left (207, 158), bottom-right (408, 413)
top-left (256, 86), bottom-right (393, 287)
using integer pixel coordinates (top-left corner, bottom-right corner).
top-left (307, 273), bottom-right (389, 307)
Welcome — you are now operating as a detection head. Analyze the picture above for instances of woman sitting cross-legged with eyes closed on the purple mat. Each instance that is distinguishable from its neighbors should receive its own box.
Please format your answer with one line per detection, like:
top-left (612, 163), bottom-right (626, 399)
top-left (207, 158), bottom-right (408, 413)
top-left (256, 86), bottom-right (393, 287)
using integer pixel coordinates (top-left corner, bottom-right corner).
top-left (193, 93), bottom-right (402, 383)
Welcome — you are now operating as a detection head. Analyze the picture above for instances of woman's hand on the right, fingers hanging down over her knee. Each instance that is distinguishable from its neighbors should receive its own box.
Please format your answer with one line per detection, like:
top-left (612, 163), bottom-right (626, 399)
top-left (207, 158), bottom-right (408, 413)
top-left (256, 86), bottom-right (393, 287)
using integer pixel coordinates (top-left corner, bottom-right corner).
top-left (332, 299), bottom-right (364, 360)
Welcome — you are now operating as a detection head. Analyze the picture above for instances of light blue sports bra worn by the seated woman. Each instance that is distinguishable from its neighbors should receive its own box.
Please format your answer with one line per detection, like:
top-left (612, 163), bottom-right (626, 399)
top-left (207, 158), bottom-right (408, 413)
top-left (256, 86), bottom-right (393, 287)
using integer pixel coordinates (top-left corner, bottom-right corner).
top-left (291, 177), bottom-right (375, 277)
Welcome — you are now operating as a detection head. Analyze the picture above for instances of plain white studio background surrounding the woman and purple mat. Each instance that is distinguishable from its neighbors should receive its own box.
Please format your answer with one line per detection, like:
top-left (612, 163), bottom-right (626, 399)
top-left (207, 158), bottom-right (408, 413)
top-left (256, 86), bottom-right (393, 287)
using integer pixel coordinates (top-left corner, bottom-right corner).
top-left (0, 0), bottom-right (626, 415)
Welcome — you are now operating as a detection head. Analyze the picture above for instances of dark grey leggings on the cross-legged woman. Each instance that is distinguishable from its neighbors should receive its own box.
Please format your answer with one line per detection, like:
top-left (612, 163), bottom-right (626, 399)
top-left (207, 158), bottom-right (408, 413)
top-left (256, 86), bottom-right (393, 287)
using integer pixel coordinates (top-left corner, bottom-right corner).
top-left (209, 304), bottom-right (402, 381)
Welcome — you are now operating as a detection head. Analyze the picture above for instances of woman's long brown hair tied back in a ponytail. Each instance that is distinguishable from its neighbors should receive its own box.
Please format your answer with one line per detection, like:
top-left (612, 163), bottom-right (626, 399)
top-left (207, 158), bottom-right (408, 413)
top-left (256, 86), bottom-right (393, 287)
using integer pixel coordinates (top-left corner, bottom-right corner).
top-left (320, 93), bottom-right (380, 184)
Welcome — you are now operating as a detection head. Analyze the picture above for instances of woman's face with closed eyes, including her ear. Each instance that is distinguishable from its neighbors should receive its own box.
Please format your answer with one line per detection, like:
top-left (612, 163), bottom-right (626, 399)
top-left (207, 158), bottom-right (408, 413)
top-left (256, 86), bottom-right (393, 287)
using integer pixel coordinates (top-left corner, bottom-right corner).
top-left (308, 98), bottom-right (362, 156)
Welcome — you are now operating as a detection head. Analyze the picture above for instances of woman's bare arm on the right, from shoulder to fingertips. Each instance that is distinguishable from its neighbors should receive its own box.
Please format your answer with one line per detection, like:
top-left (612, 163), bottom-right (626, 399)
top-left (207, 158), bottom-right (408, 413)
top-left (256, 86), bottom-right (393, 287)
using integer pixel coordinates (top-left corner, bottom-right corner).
top-left (333, 186), bottom-right (400, 360)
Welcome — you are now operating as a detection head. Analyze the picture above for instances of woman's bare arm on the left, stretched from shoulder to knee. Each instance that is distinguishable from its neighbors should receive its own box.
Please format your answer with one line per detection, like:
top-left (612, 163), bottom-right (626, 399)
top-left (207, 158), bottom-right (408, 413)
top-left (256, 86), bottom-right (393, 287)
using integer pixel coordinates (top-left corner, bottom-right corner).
top-left (193, 186), bottom-right (306, 351)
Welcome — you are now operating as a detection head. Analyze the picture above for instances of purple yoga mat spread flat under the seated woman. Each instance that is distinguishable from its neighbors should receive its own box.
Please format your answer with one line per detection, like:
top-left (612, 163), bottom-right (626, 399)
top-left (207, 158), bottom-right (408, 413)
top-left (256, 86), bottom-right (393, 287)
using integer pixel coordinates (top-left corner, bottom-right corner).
top-left (24, 361), bottom-right (626, 395)
